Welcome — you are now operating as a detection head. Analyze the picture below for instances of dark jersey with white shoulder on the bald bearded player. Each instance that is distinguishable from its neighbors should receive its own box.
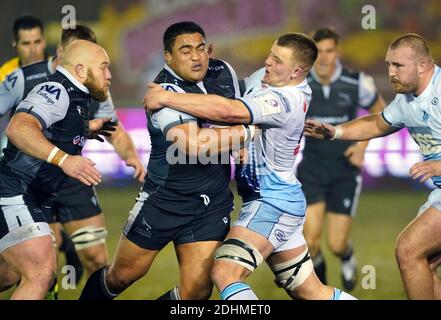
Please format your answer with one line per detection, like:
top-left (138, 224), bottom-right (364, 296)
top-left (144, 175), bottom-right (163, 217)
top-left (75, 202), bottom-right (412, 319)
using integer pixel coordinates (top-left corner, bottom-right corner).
top-left (0, 67), bottom-right (90, 197)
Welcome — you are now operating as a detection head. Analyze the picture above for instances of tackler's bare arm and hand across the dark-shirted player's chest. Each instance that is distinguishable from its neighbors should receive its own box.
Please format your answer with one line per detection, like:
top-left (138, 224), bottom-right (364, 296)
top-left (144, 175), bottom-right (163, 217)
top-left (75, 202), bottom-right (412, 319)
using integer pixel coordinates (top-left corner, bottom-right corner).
top-left (143, 83), bottom-right (251, 124)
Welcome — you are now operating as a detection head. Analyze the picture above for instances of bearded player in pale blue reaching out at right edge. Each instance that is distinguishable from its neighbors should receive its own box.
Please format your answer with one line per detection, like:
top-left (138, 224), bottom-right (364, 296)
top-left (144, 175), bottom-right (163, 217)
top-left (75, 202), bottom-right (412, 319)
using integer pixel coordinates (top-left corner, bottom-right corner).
top-left (305, 34), bottom-right (441, 300)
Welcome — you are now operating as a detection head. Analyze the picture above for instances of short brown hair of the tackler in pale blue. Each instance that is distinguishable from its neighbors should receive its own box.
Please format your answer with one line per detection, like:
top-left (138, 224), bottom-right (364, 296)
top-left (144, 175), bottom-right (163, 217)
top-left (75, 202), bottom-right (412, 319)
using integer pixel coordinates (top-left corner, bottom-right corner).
top-left (277, 33), bottom-right (318, 72)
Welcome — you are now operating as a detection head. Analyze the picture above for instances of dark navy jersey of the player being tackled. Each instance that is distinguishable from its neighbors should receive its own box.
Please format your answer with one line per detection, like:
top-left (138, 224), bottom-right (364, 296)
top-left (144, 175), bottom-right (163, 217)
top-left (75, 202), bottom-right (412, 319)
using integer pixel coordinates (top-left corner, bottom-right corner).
top-left (146, 59), bottom-right (240, 195)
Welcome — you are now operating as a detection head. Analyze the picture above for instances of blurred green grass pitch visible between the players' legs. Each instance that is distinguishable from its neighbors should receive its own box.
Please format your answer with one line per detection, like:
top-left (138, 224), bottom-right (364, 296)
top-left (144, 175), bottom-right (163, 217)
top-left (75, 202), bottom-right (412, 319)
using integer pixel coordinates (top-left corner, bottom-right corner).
top-left (0, 186), bottom-right (429, 300)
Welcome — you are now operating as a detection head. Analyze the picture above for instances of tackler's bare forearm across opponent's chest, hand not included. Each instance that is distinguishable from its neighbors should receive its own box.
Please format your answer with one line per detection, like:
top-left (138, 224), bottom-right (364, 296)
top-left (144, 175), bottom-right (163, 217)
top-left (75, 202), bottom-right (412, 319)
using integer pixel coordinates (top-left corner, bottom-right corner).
top-left (162, 92), bottom-right (251, 123)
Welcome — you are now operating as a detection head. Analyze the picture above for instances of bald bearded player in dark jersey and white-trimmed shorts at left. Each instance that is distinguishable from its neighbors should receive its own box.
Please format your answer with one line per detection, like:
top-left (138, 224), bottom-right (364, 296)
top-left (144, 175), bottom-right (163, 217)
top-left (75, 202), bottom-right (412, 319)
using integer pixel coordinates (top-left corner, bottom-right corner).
top-left (0, 40), bottom-right (111, 299)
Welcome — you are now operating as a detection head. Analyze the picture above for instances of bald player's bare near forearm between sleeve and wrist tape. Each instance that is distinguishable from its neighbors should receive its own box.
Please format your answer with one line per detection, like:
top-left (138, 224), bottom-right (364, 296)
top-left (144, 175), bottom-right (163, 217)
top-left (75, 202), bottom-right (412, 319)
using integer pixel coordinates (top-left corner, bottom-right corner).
top-left (6, 113), bottom-right (55, 160)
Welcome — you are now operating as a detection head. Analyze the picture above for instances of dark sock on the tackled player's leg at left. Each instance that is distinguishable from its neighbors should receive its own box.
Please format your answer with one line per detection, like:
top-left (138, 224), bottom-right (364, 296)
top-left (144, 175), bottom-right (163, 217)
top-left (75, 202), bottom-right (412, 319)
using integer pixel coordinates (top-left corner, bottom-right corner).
top-left (79, 266), bottom-right (118, 300)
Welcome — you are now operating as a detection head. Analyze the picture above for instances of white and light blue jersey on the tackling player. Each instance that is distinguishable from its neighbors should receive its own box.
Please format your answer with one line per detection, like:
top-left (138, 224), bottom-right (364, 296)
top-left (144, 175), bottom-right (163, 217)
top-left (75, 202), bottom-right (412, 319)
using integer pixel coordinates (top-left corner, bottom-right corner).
top-left (236, 70), bottom-right (311, 216)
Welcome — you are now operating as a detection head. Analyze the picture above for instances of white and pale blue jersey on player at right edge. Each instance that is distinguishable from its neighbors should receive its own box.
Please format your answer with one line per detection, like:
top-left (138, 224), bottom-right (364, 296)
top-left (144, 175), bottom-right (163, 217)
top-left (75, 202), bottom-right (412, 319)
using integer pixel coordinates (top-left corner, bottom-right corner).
top-left (383, 66), bottom-right (441, 188)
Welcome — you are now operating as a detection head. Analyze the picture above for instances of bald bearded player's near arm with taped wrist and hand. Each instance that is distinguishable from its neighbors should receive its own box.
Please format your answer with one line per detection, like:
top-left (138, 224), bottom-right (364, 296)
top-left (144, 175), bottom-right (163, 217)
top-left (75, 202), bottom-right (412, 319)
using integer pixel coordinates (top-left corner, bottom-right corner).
top-left (6, 112), bottom-right (101, 185)
